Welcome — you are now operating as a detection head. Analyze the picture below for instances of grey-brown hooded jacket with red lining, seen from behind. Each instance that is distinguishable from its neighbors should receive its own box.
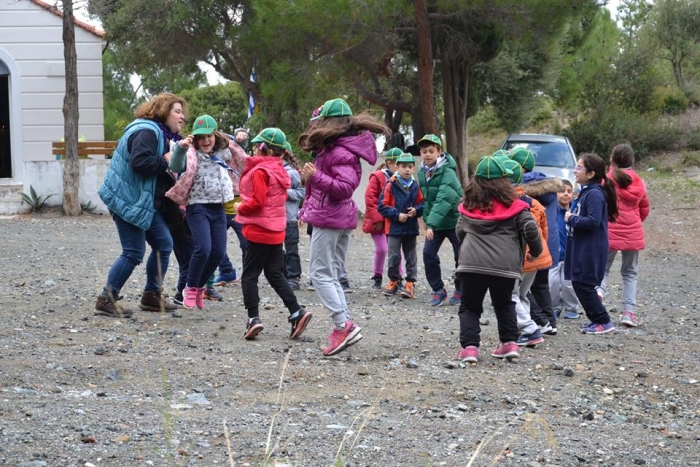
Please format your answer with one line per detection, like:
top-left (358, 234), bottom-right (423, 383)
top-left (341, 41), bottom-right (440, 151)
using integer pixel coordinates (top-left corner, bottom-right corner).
top-left (455, 199), bottom-right (543, 279)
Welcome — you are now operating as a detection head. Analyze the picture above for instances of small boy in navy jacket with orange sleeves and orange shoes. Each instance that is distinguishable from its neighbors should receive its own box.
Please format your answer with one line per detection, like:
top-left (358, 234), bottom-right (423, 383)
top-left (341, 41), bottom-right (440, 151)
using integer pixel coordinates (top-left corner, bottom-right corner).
top-left (379, 153), bottom-right (423, 298)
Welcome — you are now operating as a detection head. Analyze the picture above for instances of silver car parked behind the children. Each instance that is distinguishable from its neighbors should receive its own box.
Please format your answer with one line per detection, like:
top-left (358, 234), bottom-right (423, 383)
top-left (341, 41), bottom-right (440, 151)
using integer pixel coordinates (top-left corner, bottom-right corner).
top-left (501, 133), bottom-right (576, 186)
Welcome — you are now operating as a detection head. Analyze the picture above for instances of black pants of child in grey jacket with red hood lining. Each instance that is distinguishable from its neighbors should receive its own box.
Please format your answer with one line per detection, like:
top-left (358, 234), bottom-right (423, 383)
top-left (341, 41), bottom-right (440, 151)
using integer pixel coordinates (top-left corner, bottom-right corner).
top-left (458, 272), bottom-right (519, 347)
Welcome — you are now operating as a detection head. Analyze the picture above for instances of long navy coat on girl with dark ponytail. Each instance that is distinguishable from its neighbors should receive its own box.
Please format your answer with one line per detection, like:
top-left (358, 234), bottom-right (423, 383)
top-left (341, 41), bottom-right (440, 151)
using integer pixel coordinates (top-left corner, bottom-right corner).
top-left (564, 183), bottom-right (608, 286)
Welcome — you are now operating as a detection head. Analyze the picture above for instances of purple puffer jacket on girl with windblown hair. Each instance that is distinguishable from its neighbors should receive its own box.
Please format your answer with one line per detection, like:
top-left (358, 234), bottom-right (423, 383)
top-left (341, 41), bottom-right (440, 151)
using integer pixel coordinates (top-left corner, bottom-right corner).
top-left (299, 131), bottom-right (377, 229)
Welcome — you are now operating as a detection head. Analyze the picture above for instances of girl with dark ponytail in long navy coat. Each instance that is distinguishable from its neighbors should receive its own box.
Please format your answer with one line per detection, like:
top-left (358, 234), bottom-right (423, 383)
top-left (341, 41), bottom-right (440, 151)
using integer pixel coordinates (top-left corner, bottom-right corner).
top-left (564, 154), bottom-right (617, 334)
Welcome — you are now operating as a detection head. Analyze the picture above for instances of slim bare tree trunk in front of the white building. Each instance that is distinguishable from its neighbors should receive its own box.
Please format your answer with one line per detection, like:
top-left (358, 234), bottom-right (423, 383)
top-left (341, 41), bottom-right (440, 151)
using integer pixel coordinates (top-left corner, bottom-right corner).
top-left (62, 0), bottom-right (82, 216)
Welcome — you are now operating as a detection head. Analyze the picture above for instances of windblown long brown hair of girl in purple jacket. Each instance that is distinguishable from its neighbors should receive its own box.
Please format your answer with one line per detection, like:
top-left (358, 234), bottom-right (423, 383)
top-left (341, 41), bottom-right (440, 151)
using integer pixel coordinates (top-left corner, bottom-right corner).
top-left (299, 113), bottom-right (391, 152)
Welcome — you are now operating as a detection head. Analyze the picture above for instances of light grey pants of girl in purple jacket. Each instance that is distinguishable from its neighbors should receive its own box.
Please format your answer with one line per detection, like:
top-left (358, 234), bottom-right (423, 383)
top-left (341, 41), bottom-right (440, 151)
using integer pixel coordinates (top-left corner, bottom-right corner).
top-left (309, 227), bottom-right (352, 326)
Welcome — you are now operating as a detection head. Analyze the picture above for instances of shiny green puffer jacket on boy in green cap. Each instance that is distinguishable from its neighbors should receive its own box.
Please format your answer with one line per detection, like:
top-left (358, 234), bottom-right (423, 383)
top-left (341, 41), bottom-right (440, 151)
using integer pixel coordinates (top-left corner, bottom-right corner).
top-left (418, 152), bottom-right (464, 230)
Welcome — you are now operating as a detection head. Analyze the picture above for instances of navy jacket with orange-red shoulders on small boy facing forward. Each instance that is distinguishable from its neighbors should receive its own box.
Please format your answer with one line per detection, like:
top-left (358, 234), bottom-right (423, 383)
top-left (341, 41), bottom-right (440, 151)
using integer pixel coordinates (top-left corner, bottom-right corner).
top-left (378, 176), bottom-right (424, 237)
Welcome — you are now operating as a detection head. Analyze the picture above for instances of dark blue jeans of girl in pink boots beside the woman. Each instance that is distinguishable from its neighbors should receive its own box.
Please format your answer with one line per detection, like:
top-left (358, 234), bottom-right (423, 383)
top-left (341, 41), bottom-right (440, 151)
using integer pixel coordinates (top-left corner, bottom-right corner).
top-left (186, 204), bottom-right (226, 287)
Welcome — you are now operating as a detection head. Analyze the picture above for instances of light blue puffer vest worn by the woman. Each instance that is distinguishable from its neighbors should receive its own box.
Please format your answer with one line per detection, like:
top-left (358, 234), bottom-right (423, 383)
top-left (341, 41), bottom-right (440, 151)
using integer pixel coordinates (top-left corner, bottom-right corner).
top-left (98, 119), bottom-right (167, 230)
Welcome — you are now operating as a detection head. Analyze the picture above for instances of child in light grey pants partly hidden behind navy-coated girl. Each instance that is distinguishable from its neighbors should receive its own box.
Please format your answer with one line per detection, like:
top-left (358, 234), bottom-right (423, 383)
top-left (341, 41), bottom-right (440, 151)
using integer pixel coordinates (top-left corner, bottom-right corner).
top-left (549, 179), bottom-right (579, 319)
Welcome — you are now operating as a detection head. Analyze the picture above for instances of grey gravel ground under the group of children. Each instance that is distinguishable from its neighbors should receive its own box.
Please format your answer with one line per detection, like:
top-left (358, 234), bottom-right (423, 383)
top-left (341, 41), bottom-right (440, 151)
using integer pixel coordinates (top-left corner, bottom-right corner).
top-left (0, 169), bottom-right (700, 467)
